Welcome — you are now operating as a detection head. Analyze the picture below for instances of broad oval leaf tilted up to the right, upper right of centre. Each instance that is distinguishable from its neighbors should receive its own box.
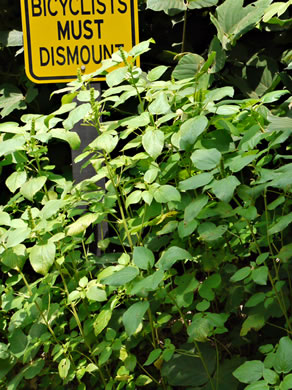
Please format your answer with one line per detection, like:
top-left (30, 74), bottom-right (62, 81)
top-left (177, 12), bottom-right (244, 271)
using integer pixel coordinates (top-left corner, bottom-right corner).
top-left (178, 115), bottom-right (208, 150)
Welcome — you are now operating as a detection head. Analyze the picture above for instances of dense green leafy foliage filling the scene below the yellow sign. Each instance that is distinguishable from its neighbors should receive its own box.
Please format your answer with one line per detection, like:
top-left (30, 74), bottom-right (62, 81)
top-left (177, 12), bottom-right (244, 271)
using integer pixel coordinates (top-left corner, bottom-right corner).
top-left (0, 0), bottom-right (292, 390)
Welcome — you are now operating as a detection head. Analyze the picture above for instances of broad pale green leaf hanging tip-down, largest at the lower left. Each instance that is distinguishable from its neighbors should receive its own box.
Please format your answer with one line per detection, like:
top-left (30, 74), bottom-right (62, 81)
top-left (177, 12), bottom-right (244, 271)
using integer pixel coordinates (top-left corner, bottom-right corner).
top-left (29, 242), bottom-right (56, 275)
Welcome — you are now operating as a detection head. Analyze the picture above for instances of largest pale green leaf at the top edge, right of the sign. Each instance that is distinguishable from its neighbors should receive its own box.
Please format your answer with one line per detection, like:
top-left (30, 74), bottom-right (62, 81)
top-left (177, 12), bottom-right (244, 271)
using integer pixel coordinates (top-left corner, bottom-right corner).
top-left (210, 0), bottom-right (271, 50)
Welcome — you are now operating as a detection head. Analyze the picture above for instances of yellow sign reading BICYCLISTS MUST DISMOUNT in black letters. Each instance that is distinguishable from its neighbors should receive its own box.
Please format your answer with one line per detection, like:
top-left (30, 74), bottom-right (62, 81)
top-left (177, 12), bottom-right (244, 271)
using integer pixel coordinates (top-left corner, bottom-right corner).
top-left (21, 0), bottom-right (138, 83)
